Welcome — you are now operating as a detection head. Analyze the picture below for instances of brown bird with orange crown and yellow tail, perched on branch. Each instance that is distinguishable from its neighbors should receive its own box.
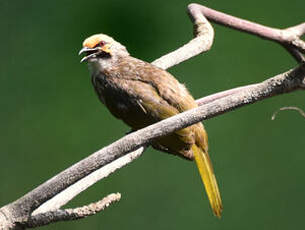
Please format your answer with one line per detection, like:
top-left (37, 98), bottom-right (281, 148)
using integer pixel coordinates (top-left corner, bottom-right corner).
top-left (79, 34), bottom-right (223, 218)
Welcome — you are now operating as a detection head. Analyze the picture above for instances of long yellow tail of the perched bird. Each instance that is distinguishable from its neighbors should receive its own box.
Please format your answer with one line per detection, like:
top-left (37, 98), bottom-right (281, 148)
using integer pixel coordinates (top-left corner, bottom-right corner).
top-left (192, 144), bottom-right (222, 218)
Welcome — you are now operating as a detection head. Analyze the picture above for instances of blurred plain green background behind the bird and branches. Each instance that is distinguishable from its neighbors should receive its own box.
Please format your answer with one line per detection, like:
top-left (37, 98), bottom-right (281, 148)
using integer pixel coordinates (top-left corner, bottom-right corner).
top-left (0, 0), bottom-right (305, 230)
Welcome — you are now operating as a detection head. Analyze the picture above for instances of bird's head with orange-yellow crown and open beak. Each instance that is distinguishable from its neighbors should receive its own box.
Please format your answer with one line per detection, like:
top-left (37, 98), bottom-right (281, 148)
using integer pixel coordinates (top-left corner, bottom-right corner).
top-left (79, 34), bottom-right (128, 62)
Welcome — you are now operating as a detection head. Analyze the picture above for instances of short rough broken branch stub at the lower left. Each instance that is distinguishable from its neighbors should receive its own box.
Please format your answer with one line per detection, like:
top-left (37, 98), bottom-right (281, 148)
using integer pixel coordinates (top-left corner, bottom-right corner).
top-left (25, 193), bottom-right (121, 228)
